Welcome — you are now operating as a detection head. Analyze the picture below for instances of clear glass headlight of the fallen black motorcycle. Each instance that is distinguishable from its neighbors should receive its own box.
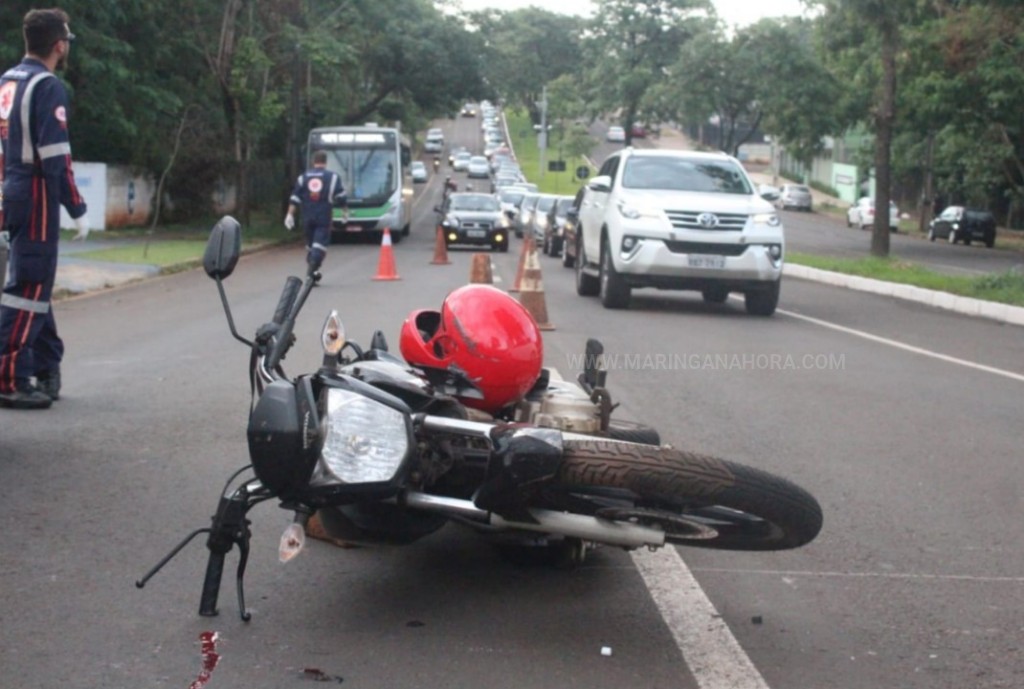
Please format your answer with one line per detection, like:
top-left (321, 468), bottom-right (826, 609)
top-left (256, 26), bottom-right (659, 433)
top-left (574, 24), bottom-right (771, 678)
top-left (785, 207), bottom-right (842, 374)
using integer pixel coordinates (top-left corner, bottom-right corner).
top-left (321, 388), bottom-right (409, 483)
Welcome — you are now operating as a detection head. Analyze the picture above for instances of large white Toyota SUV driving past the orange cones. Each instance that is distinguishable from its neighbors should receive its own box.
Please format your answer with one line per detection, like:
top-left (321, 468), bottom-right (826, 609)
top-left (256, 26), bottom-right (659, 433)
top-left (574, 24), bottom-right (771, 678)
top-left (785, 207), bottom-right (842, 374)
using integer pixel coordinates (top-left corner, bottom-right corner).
top-left (575, 147), bottom-right (784, 315)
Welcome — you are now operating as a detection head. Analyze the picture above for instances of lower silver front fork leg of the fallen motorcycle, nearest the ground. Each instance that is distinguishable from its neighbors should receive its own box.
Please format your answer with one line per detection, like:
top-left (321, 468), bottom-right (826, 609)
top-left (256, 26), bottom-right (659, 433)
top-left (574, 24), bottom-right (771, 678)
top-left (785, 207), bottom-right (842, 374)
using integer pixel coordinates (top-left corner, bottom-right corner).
top-left (403, 491), bottom-right (665, 548)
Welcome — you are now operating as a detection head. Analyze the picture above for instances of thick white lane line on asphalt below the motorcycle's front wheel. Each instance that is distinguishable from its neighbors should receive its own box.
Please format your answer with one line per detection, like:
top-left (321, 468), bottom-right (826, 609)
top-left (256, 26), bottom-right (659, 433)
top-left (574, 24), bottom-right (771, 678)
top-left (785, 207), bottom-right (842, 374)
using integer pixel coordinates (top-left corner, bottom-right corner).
top-left (631, 546), bottom-right (769, 689)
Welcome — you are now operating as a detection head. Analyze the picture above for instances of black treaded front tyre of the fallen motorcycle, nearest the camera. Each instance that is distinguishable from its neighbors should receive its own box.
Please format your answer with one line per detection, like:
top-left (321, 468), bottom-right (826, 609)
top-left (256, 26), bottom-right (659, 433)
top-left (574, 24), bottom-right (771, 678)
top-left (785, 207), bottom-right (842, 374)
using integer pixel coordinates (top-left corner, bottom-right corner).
top-left (555, 439), bottom-right (822, 551)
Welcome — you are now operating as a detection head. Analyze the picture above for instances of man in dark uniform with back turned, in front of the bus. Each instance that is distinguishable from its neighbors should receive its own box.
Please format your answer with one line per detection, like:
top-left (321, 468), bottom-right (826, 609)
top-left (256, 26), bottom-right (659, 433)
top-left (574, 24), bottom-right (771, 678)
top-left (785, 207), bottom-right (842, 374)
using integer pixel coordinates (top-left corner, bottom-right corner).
top-left (285, 150), bottom-right (347, 274)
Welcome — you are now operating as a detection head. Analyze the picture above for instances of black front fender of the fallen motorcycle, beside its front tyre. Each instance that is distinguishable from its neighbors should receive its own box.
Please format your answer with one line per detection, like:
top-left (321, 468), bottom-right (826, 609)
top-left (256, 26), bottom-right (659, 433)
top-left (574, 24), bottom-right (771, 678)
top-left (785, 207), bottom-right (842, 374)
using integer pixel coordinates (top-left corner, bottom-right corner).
top-left (473, 425), bottom-right (562, 522)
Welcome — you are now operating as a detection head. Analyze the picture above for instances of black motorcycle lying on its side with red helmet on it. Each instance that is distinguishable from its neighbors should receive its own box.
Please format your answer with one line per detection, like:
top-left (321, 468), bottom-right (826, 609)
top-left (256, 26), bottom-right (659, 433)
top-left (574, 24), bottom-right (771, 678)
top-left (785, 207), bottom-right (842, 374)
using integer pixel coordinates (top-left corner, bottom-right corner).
top-left (136, 217), bottom-right (822, 620)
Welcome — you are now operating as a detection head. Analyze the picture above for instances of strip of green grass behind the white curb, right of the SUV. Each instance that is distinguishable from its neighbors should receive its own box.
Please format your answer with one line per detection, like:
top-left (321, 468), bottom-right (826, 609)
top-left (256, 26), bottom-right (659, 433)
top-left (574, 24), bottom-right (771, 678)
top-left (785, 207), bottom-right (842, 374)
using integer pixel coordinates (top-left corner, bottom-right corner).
top-left (786, 252), bottom-right (1024, 306)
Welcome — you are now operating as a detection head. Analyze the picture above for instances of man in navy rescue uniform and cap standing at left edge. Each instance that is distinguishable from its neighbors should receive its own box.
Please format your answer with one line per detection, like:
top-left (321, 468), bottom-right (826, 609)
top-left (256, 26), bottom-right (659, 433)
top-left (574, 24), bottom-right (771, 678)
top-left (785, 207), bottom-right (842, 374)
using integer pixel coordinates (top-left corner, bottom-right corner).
top-left (0, 9), bottom-right (89, 410)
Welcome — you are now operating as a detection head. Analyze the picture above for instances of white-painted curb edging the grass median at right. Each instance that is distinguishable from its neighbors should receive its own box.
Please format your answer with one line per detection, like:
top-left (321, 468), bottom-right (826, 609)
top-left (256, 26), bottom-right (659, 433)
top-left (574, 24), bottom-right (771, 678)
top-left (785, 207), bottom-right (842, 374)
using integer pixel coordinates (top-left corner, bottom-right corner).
top-left (782, 263), bottom-right (1024, 326)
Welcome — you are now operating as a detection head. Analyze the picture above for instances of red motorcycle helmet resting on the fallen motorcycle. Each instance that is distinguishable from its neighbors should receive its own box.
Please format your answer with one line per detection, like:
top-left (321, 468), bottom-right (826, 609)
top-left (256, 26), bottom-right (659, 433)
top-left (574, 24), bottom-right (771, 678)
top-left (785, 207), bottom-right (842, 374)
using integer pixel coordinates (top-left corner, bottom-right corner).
top-left (398, 285), bottom-right (544, 414)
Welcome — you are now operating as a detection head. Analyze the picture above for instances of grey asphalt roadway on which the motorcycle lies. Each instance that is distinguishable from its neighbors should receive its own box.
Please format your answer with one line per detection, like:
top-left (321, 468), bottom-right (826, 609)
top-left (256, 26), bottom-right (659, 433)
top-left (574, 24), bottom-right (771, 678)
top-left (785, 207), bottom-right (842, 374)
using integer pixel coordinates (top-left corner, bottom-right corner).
top-left (0, 118), bottom-right (1024, 689)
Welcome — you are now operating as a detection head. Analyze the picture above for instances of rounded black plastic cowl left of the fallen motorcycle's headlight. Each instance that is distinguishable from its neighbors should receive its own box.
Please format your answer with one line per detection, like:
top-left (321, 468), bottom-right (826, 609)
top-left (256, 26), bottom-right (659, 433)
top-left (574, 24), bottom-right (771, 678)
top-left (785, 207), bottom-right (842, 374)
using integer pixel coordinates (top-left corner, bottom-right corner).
top-left (248, 378), bottom-right (321, 499)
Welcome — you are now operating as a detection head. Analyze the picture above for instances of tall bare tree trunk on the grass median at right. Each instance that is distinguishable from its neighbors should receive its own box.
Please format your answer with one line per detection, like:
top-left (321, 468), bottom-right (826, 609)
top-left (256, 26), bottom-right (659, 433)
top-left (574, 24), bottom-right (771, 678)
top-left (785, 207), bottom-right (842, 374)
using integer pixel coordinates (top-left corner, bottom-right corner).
top-left (871, 23), bottom-right (897, 258)
